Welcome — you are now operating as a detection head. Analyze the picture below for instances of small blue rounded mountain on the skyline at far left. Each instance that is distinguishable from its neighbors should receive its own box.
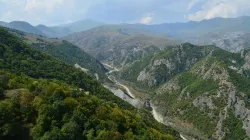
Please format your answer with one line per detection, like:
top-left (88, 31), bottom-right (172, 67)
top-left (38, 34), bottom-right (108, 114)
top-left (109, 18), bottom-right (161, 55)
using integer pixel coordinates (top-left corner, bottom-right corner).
top-left (7, 21), bottom-right (46, 36)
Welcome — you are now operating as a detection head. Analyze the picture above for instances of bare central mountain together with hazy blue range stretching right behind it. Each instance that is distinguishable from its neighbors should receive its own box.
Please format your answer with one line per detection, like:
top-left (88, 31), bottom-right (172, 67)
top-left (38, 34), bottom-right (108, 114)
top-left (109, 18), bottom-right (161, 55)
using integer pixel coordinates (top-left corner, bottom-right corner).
top-left (62, 17), bottom-right (250, 67)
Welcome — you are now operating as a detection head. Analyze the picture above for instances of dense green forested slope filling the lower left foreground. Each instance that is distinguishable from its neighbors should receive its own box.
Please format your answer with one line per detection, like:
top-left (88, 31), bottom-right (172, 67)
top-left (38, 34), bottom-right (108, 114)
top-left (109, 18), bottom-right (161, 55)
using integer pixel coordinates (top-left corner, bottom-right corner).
top-left (0, 28), bottom-right (180, 140)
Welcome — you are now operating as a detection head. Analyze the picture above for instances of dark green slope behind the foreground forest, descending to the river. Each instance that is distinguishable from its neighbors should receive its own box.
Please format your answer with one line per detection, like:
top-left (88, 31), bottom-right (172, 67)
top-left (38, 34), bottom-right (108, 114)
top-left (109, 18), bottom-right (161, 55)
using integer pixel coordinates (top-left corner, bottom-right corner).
top-left (8, 29), bottom-right (107, 81)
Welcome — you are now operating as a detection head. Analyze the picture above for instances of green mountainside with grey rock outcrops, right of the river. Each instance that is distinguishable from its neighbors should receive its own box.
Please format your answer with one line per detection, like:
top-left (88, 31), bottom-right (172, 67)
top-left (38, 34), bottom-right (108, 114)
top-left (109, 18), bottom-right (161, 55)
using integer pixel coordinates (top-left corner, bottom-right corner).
top-left (117, 43), bottom-right (250, 140)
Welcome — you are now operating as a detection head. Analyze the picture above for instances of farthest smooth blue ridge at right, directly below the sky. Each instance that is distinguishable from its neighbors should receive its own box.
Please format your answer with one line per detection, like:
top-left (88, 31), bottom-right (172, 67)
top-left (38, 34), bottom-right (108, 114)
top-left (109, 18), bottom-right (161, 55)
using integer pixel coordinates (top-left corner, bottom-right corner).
top-left (142, 16), bottom-right (250, 37)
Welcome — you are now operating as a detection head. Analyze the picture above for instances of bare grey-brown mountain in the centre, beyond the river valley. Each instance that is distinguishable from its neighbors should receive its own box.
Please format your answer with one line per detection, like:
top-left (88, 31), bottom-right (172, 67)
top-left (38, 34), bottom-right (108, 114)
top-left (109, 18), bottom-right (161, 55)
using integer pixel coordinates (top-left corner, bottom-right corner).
top-left (62, 25), bottom-right (176, 67)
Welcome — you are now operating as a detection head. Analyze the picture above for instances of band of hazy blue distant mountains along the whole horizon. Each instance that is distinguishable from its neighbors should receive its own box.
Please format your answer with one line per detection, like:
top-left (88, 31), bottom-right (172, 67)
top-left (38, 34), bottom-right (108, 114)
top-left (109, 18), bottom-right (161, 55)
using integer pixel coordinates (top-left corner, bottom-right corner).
top-left (0, 16), bottom-right (250, 52)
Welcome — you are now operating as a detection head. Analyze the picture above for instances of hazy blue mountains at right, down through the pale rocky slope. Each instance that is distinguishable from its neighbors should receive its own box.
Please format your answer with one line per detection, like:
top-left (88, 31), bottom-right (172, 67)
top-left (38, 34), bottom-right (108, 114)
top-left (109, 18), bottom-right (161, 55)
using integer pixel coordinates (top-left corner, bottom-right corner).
top-left (125, 16), bottom-right (250, 52)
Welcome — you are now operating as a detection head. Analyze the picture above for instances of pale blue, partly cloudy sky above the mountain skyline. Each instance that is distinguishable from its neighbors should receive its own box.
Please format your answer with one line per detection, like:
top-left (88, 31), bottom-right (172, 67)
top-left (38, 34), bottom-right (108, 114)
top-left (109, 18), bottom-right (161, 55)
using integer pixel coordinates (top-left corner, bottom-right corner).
top-left (0, 0), bottom-right (250, 26)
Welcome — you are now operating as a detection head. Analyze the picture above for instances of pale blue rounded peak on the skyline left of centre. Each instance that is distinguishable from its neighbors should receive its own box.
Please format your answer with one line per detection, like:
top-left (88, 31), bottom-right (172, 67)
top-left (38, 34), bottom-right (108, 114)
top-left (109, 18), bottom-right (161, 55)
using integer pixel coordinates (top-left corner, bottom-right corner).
top-left (62, 19), bottom-right (105, 32)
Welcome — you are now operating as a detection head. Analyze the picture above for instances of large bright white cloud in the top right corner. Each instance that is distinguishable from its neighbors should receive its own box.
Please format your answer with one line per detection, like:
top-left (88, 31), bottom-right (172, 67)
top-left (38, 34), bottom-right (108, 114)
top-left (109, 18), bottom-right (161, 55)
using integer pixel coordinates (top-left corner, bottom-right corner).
top-left (188, 0), bottom-right (250, 21)
